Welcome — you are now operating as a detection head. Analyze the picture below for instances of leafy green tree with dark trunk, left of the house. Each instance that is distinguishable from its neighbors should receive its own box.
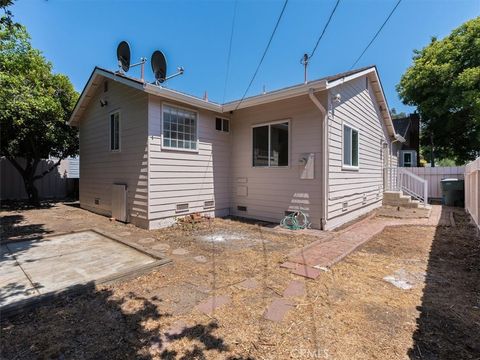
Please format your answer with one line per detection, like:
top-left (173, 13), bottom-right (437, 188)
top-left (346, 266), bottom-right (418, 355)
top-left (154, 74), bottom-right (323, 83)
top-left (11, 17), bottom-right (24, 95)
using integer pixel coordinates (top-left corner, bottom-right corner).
top-left (0, 7), bottom-right (78, 206)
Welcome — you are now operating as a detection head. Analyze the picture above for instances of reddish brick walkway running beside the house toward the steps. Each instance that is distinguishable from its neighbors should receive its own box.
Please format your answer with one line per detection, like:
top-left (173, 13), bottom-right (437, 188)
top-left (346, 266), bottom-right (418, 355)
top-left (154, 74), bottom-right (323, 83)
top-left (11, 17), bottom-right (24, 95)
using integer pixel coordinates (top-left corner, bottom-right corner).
top-left (281, 205), bottom-right (448, 278)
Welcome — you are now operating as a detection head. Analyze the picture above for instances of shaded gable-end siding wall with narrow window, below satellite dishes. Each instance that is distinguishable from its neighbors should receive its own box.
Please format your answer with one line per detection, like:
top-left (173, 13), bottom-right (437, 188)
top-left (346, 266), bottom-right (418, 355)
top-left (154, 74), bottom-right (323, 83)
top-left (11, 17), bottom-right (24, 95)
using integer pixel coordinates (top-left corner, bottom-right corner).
top-left (79, 81), bottom-right (148, 227)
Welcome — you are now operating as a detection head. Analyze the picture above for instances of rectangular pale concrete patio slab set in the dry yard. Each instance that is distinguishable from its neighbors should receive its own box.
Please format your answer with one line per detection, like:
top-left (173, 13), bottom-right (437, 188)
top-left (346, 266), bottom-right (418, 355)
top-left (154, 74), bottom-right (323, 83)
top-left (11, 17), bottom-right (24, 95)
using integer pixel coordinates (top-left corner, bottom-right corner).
top-left (0, 230), bottom-right (170, 309)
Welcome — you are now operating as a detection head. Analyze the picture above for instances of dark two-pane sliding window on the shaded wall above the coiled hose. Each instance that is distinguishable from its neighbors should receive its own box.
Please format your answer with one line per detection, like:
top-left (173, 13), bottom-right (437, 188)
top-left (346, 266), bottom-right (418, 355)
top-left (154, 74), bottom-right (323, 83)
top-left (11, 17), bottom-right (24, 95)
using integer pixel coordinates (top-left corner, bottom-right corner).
top-left (252, 121), bottom-right (290, 167)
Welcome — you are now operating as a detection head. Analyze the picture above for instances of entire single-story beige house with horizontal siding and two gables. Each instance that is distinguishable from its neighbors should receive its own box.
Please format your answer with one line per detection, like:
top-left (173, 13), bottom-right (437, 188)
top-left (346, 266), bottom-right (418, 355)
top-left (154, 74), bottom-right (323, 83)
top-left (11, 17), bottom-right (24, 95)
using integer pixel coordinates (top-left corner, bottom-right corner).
top-left (69, 66), bottom-right (403, 229)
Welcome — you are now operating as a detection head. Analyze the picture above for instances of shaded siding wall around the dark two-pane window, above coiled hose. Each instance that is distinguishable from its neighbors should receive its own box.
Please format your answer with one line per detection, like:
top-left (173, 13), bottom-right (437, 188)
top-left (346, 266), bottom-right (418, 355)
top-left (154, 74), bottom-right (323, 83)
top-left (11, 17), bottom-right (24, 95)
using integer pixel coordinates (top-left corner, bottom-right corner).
top-left (231, 95), bottom-right (326, 228)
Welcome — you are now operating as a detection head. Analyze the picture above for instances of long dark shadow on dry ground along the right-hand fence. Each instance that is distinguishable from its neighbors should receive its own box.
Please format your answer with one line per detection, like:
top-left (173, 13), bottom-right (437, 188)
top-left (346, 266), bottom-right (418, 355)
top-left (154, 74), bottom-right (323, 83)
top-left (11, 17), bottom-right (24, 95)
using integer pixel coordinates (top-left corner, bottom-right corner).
top-left (409, 210), bottom-right (480, 360)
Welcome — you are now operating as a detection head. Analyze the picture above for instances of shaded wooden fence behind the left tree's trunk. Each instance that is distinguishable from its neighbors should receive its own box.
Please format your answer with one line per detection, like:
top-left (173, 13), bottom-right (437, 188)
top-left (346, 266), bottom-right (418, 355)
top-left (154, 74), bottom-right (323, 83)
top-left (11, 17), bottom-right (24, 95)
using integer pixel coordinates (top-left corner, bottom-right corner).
top-left (0, 158), bottom-right (78, 200)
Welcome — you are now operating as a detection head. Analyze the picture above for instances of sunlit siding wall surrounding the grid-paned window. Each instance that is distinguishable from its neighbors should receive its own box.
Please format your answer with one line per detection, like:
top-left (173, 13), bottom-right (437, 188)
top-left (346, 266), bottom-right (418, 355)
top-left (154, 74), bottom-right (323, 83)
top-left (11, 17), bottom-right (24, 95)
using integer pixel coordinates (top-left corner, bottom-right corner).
top-left (148, 95), bottom-right (232, 228)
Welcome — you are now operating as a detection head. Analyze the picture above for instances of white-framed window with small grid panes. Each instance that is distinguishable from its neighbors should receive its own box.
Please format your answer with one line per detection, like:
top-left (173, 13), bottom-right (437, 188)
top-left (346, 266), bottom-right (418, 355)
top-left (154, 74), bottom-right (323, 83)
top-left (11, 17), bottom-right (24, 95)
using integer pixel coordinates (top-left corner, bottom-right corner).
top-left (163, 105), bottom-right (197, 150)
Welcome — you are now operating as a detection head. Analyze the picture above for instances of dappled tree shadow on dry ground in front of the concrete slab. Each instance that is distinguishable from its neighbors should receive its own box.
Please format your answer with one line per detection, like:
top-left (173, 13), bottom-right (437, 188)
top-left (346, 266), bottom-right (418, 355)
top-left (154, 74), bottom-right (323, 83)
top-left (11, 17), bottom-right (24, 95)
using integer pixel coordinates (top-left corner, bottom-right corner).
top-left (0, 284), bottom-right (253, 360)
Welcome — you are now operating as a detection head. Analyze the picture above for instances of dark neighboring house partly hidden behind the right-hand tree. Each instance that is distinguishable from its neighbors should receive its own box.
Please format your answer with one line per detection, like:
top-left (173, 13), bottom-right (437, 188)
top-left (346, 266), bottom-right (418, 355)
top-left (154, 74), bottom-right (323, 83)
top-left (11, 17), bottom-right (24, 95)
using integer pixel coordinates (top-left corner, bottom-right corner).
top-left (393, 113), bottom-right (420, 167)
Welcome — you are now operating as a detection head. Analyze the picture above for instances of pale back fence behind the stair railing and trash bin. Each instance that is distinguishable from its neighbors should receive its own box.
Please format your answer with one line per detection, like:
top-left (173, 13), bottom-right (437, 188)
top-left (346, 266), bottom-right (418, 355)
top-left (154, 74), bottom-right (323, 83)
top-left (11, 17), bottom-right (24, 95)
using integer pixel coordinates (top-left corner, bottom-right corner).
top-left (405, 166), bottom-right (465, 199)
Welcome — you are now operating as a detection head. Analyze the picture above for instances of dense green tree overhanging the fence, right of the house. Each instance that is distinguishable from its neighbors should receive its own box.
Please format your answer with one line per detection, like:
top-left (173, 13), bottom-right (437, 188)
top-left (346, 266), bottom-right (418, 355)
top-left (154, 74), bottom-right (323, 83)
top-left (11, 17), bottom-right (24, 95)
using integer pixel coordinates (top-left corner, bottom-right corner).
top-left (397, 17), bottom-right (480, 163)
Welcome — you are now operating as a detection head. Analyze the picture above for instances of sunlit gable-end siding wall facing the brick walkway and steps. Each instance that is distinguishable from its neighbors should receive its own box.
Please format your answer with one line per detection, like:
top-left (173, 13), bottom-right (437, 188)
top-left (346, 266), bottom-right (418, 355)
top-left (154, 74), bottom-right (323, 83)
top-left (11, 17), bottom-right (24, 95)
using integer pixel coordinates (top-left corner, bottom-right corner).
top-left (326, 77), bottom-right (389, 229)
